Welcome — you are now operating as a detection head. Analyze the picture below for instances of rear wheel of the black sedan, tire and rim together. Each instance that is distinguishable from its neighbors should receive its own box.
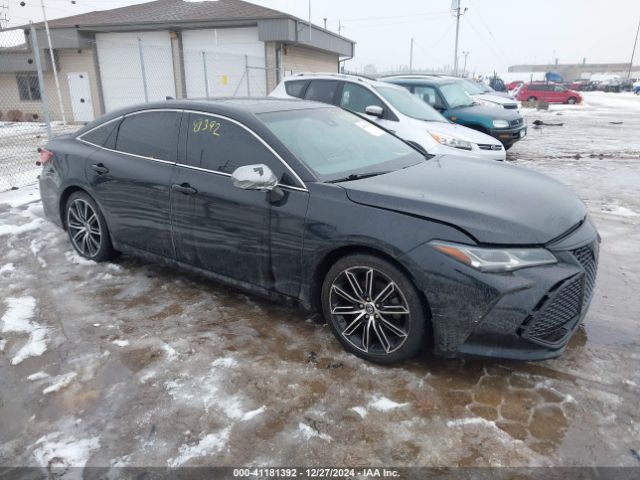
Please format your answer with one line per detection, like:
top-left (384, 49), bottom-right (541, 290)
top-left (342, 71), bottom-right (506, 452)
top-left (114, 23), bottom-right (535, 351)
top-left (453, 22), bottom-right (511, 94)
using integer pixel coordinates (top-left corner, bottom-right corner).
top-left (65, 191), bottom-right (114, 262)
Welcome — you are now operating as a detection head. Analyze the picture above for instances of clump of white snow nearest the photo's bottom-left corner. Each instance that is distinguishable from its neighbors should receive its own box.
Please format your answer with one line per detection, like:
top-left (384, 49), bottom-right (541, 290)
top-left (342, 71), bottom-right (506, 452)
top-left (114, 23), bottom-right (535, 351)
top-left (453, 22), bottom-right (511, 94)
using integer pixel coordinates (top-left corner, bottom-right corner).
top-left (33, 432), bottom-right (100, 468)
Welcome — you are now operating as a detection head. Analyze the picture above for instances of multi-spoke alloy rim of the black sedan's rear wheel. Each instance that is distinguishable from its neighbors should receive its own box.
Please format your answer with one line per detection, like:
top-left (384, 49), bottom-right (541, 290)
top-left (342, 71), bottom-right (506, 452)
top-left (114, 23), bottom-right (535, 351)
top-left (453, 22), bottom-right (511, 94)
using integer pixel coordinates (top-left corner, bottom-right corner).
top-left (67, 198), bottom-right (102, 258)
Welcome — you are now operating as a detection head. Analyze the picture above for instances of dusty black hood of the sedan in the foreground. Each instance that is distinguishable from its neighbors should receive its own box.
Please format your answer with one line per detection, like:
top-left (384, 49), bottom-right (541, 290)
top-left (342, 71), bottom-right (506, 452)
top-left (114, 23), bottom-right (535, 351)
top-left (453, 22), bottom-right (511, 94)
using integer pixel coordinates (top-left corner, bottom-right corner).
top-left (340, 155), bottom-right (587, 245)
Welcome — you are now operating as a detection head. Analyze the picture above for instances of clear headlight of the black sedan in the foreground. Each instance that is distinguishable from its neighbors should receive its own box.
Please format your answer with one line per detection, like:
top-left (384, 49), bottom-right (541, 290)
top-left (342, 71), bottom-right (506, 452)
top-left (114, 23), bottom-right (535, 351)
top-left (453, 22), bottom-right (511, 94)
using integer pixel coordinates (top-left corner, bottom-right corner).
top-left (430, 241), bottom-right (558, 272)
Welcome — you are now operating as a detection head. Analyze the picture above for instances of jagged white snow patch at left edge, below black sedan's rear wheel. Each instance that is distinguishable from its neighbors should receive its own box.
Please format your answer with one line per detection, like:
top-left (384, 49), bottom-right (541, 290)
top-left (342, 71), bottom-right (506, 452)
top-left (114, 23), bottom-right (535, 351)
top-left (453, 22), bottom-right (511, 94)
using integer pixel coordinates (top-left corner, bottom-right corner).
top-left (0, 296), bottom-right (49, 365)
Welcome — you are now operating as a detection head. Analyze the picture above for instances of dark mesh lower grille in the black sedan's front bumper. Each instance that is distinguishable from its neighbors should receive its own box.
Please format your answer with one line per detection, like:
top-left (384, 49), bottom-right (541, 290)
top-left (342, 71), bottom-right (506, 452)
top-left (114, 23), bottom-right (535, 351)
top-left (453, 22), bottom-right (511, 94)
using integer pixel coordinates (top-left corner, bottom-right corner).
top-left (527, 275), bottom-right (582, 343)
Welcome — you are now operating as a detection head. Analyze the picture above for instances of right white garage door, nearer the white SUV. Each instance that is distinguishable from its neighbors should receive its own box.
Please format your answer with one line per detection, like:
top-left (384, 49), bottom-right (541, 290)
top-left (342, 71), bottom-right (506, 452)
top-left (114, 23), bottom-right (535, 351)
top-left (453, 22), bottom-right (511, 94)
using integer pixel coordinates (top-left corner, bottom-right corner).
top-left (182, 27), bottom-right (267, 98)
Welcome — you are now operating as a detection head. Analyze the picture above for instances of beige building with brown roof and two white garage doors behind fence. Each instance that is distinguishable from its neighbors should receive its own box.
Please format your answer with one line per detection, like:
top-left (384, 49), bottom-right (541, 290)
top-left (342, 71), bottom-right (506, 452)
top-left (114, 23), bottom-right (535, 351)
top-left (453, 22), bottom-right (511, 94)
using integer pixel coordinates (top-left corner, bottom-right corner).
top-left (0, 0), bottom-right (355, 122)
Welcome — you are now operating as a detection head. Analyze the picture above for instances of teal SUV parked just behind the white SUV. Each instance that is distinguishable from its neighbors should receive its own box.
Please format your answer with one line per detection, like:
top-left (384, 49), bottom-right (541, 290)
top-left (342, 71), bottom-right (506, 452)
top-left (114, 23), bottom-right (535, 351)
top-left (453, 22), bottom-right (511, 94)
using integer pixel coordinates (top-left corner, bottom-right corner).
top-left (383, 76), bottom-right (527, 150)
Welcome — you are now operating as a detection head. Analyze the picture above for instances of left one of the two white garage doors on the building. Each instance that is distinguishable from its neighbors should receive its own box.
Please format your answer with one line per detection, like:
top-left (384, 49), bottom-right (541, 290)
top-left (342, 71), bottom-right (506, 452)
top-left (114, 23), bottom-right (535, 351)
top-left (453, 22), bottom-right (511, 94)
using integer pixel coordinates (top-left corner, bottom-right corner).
top-left (96, 31), bottom-right (176, 111)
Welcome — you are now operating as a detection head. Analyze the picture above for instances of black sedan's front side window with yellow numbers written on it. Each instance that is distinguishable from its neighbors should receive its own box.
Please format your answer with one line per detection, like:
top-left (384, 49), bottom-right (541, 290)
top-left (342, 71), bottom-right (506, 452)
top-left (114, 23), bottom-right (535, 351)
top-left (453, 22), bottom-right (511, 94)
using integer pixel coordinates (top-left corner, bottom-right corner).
top-left (187, 113), bottom-right (297, 186)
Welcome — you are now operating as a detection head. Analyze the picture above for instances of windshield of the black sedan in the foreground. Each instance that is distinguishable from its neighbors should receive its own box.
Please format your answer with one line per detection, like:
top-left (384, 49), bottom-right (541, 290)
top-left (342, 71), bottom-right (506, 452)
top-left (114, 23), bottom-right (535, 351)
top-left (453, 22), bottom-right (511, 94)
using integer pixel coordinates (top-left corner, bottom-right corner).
top-left (259, 108), bottom-right (425, 182)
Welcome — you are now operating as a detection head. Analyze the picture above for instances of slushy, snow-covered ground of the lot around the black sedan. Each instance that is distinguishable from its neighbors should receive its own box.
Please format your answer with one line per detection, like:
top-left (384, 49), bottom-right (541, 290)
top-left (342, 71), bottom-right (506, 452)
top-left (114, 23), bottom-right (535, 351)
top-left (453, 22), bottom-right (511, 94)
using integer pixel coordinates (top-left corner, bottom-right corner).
top-left (0, 93), bottom-right (640, 467)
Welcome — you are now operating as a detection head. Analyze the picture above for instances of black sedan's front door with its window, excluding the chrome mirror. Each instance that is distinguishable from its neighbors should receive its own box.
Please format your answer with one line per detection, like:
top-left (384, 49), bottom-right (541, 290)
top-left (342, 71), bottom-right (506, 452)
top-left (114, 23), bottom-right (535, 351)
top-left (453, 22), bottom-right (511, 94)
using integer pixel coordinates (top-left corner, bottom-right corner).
top-left (171, 113), bottom-right (308, 295)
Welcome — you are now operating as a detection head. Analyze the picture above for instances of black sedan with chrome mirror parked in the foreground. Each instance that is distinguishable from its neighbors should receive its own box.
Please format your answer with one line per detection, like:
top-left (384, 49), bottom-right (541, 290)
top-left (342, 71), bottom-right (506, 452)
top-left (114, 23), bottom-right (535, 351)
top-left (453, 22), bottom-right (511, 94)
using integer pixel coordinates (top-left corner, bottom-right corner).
top-left (40, 99), bottom-right (599, 363)
